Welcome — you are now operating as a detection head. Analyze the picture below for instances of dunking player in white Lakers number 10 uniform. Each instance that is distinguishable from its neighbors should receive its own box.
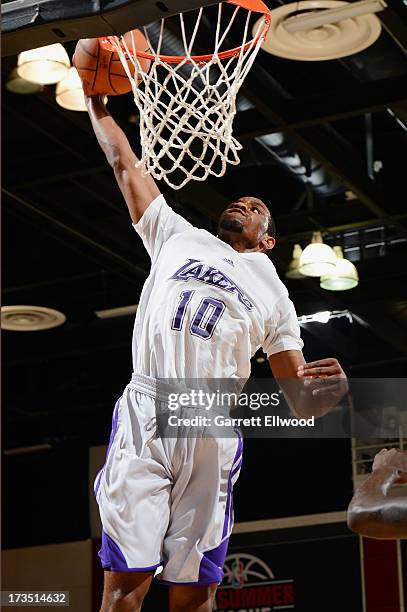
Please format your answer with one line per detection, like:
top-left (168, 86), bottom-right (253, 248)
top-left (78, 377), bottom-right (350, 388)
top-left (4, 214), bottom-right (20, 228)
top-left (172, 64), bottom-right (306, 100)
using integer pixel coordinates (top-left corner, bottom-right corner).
top-left (85, 92), bottom-right (346, 612)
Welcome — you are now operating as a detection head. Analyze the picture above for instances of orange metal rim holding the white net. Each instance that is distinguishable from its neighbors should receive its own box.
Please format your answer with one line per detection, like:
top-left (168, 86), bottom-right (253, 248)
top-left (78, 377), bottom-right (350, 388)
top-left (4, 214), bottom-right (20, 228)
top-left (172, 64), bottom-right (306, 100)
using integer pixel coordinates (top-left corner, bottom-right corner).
top-left (98, 0), bottom-right (271, 64)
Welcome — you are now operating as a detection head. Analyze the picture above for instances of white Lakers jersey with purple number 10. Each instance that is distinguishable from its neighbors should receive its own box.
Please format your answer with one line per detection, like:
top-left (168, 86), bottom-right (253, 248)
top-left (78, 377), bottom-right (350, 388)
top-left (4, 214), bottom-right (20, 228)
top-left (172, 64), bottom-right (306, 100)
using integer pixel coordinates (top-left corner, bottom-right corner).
top-left (133, 195), bottom-right (303, 379)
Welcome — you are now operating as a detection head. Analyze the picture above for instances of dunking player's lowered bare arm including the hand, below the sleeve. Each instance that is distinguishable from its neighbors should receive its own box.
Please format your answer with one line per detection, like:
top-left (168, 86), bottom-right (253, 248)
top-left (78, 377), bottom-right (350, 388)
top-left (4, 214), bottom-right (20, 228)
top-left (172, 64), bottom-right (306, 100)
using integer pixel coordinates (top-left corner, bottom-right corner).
top-left (269, 350), bottom-right (348, 418)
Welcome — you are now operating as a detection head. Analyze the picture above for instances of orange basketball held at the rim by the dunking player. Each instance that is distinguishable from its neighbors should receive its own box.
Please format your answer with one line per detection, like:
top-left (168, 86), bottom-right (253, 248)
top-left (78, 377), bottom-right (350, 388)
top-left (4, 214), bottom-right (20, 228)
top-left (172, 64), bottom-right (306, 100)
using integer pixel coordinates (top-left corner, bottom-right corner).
top-left (72, 30), bottom-right (150, 96)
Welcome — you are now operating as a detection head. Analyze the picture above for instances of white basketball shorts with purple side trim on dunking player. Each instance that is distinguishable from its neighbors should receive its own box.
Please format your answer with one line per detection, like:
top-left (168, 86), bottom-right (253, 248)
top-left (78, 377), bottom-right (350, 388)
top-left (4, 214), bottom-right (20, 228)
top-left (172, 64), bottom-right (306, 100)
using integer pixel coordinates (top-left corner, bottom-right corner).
top-left (95, 375), bottom-right (243, 585)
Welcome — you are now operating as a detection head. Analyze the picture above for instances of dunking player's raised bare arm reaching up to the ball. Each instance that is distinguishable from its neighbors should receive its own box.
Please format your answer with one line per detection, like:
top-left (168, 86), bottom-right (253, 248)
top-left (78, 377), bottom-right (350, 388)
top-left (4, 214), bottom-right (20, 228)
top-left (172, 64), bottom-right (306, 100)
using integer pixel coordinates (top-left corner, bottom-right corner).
top-left (85, 90), bottom-right (160, 223)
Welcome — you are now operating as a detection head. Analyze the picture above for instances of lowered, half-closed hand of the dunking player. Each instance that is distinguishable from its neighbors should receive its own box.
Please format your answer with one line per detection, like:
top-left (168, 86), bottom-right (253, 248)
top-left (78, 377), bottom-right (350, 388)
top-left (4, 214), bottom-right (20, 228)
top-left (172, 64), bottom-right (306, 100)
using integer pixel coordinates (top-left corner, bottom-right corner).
top-left (297, 357), bottom-right (349, 400)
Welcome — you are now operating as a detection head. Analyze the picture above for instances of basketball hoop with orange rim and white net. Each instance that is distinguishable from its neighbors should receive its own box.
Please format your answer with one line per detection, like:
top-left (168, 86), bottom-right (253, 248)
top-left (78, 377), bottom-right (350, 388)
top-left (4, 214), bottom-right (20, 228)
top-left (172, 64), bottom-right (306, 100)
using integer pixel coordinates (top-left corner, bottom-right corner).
top-left (99, 0), bottom-right (270, 189)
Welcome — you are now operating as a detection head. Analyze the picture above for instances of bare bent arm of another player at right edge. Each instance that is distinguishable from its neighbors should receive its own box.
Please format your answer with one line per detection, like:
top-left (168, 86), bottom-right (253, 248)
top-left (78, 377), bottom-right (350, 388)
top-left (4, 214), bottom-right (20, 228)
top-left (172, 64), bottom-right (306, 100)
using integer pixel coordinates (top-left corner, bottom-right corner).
top-left (348, 448), bottom-right (407, 540)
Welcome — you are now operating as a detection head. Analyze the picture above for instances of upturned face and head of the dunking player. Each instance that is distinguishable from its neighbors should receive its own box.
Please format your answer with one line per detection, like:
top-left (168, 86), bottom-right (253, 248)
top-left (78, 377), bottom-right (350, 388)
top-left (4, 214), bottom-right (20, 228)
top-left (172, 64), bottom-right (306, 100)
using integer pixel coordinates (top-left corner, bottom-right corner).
top-left (219, 196), bottom-right (273, 250)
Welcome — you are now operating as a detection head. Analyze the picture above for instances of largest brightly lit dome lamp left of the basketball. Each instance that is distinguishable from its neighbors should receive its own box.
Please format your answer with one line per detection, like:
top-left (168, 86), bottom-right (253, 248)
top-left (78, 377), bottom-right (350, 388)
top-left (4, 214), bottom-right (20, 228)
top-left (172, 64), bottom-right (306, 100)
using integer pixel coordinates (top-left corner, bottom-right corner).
top-left (17, 43), bottom-right (71, 85)
